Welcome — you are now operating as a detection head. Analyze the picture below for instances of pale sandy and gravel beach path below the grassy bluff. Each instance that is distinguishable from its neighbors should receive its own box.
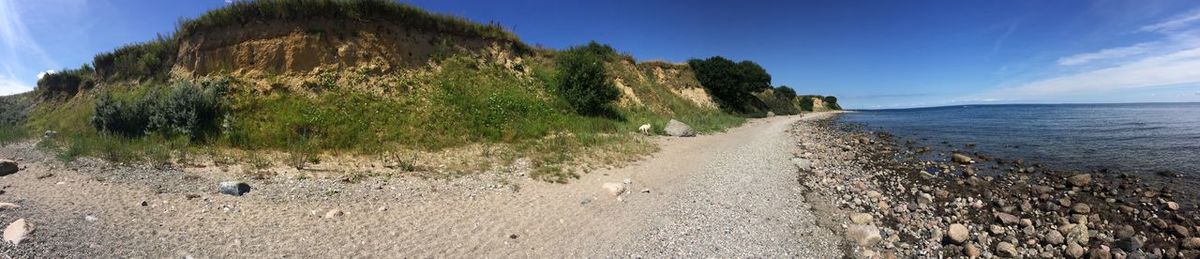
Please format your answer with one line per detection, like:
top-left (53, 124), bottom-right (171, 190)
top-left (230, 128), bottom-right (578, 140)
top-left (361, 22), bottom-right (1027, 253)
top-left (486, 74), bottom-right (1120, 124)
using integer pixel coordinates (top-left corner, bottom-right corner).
top-left (0, 114), bottom-right (840, 258)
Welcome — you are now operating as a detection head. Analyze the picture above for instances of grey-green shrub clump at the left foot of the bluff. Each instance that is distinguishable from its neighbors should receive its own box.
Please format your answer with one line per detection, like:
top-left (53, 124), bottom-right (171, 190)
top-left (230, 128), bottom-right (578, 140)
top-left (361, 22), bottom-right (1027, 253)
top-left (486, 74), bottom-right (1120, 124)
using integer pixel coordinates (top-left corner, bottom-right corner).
top-left (91, 82), bottom-right (226, 139)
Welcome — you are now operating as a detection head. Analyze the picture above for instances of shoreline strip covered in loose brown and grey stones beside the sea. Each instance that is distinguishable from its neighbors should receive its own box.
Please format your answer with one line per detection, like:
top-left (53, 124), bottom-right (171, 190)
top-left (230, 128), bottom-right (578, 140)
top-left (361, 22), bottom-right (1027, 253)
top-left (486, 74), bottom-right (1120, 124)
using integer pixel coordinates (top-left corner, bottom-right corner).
top-left (791, 112), bottom-right (1200, 258)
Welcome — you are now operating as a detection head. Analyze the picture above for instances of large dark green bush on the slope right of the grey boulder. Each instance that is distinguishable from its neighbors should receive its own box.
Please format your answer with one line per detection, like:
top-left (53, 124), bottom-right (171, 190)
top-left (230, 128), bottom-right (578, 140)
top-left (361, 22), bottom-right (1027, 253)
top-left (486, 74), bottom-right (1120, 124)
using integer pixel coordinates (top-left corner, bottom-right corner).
top-left (688, 56), bottom-right (770, 113)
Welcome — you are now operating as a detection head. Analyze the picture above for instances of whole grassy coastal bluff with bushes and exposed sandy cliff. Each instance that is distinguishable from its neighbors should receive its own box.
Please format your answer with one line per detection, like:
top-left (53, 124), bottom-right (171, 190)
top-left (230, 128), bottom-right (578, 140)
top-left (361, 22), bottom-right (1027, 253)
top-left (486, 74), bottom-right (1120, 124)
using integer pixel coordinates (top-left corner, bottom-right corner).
top-left (0, 0), bottom-right (836, 181)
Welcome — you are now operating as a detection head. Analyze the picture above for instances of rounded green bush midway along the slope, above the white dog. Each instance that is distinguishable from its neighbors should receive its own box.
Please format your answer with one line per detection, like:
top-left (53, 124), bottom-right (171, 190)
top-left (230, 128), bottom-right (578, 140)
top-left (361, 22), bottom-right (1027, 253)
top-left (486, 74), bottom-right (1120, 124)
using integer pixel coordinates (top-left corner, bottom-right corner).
top-left (556, 42), bottom-right (620, 115)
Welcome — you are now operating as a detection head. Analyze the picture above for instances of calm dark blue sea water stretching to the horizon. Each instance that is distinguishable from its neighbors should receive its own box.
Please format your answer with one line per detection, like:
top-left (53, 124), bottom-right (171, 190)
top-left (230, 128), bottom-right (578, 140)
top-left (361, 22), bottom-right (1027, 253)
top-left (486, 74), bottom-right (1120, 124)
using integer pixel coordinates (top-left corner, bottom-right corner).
top-left (839, 103), bottom-right (1200, 178)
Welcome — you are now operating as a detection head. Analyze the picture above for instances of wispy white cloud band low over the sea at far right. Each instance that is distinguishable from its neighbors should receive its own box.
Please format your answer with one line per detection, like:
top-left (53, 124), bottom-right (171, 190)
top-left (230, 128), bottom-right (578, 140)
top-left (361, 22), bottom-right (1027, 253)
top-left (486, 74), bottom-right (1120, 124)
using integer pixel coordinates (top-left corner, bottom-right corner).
top-left (978, 47), bottom-right (1200, 100)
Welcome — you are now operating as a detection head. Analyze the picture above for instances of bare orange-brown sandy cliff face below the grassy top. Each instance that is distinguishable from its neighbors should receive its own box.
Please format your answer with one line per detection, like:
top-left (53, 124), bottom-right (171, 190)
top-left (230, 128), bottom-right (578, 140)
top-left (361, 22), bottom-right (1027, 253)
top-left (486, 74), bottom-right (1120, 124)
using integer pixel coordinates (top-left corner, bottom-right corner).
top-left (173, 20), bottom-right (514, 77)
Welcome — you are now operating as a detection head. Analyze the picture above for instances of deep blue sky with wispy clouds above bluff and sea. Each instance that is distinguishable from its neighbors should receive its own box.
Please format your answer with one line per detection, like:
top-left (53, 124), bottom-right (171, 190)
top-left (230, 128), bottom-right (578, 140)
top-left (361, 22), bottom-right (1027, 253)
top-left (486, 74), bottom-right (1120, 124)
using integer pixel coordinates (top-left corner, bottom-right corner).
top-left (0, 0), bottom-right (1200, 108)
